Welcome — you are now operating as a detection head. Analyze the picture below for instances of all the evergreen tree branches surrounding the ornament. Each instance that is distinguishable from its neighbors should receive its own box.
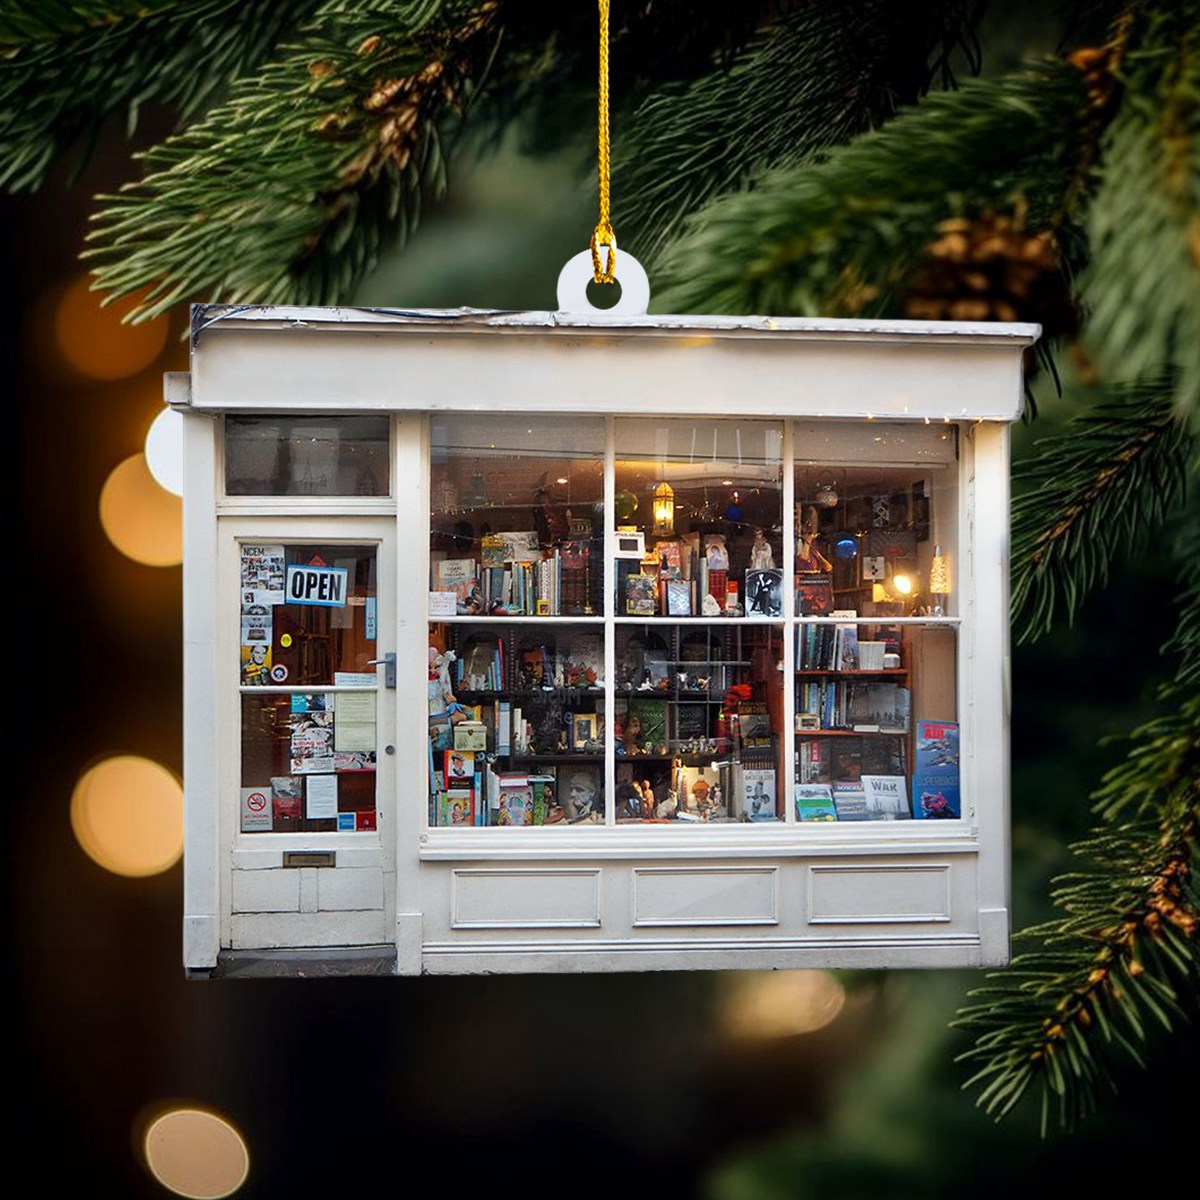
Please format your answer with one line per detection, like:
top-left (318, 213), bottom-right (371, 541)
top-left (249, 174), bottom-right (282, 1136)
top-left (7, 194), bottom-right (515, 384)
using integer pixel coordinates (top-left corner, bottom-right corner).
top-left (0, 0), bottom-right (1200, 1142)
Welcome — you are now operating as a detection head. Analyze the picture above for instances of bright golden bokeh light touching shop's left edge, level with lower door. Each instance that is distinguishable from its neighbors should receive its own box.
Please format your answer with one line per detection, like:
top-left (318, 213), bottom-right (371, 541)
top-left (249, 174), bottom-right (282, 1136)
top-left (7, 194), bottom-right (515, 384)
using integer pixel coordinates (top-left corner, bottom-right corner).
top-left (71, 755), bottom-right (184, 876)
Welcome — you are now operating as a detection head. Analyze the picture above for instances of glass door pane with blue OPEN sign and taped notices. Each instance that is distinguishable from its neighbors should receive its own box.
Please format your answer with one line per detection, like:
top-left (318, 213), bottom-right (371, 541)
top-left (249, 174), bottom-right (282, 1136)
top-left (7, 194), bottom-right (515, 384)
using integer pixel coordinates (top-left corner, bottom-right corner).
top-left (239, 542), bottom-right (378, 834)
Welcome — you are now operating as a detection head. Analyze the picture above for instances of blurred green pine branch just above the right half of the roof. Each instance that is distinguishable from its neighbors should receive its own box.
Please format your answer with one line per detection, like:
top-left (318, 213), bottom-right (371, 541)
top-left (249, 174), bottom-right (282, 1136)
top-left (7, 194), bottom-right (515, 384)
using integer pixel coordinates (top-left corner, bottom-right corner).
top-left (655, 61), bottom-right (1088, 319)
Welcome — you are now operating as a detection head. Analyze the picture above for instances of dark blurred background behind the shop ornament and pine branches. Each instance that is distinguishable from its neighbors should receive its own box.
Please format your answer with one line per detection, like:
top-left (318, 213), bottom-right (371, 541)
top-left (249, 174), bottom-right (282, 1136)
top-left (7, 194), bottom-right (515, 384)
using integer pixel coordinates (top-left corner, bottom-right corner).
top-left (11, 18), bottom-right (1198, 1200)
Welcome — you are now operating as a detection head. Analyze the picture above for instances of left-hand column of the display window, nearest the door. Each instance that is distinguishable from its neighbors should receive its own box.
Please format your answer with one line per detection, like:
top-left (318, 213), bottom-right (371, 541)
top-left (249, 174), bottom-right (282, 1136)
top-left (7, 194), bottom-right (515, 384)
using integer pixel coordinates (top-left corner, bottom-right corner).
top-left (427, 414), bottom-right (608, 826)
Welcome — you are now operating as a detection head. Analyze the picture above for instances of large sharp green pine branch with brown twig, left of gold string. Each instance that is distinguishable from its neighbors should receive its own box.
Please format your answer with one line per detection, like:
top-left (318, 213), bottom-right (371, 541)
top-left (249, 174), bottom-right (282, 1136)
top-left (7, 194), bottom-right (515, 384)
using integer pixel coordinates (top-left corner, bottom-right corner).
top-left (85, 0), bottom-right (499, 319)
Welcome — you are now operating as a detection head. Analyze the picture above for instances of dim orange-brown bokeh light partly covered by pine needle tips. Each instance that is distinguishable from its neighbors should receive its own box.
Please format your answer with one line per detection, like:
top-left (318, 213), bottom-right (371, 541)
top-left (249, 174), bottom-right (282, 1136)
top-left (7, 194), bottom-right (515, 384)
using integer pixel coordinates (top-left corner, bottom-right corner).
top-left (54, 275), bottom-right (169, 379)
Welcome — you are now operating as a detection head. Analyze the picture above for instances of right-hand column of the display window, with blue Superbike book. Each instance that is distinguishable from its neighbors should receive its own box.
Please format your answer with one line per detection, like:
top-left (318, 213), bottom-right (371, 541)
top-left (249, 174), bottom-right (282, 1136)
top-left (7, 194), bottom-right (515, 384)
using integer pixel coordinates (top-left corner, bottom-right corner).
top-left (792, 422), bottom-right (962, 822)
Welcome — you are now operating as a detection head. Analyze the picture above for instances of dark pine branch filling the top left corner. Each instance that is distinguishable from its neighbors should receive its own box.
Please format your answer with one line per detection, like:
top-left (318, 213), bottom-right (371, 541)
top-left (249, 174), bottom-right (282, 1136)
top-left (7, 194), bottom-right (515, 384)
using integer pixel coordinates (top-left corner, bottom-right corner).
top-left (0, 0), bottom-right (317, 192)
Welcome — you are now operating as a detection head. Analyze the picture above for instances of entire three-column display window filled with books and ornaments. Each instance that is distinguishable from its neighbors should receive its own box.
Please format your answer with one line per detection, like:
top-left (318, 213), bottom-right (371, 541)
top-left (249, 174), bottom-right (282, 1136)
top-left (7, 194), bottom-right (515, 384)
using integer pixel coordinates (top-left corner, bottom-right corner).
top-left (427, 414), bottom-right (962, 835)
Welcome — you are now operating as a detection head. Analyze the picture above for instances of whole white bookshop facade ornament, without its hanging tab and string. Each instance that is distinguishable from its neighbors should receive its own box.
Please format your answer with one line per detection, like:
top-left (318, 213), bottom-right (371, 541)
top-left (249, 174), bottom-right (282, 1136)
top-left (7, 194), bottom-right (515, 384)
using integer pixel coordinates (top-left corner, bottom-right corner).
top-left (174, 307), bottom-right (1038, 974)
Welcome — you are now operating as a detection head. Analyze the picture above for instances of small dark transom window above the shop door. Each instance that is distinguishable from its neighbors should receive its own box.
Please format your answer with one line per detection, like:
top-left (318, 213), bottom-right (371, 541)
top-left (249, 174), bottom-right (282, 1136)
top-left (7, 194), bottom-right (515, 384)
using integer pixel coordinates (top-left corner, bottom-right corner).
top-left (224, 415), bottom-right (390, 496)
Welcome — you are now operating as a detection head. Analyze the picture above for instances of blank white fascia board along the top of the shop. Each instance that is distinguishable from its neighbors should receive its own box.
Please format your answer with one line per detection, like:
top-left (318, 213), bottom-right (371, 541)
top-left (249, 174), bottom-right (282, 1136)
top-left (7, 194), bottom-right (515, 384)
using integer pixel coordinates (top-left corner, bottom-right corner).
top-left (188, 306), bottom-right (1040, 421)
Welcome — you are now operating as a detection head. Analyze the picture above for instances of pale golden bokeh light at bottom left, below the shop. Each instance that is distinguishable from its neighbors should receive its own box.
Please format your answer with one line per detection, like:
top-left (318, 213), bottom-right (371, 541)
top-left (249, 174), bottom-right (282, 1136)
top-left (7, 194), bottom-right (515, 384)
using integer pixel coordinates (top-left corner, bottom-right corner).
top-left (142, 1108), bottom-right (250, 1200)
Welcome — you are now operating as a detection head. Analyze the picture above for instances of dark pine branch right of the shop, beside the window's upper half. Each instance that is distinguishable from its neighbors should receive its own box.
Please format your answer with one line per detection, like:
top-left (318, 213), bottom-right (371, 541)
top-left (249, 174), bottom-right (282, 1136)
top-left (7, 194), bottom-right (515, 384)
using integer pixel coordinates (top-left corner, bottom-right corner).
top-left (1010, 385), bottom-right (1194, 642)
